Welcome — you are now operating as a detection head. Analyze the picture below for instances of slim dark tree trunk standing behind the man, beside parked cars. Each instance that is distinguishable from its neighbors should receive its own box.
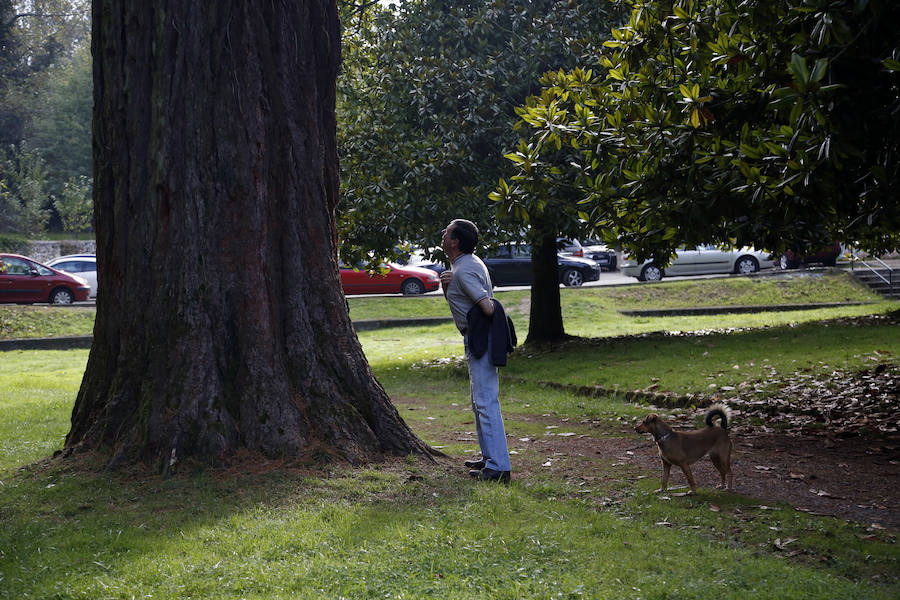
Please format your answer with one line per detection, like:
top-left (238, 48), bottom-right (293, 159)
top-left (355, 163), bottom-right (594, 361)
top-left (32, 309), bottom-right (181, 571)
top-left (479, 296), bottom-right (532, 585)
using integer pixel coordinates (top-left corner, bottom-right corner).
top-left (525, 233), bottom-right (566, 344)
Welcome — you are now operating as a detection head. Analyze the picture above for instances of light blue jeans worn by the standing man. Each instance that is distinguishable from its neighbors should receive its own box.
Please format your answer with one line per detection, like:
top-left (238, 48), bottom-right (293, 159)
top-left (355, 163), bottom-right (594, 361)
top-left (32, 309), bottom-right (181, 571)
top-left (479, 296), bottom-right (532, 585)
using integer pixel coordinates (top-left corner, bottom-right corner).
top-left (463, 338), bottom-right (510, 471)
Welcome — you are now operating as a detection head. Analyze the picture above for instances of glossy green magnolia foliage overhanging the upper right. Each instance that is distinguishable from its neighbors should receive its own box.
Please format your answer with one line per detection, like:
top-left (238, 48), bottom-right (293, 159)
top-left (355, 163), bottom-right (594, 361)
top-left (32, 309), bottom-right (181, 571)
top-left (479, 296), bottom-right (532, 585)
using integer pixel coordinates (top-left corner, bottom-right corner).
top-left (494, 0), bottom-right (900, 264)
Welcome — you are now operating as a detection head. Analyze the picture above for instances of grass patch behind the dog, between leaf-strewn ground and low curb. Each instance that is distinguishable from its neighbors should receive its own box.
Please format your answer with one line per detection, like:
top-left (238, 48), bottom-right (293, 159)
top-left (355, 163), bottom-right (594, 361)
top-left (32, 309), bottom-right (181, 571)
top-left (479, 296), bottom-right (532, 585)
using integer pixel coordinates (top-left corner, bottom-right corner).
top-left (505, 313), bottom-right (900, 393)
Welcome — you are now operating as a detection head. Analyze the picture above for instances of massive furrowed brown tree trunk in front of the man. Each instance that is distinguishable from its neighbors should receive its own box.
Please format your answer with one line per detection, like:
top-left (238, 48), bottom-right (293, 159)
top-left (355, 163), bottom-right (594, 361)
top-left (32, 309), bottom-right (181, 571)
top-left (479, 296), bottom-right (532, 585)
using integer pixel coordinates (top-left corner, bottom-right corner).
top-left (66, 0), bottom-right (428, 470)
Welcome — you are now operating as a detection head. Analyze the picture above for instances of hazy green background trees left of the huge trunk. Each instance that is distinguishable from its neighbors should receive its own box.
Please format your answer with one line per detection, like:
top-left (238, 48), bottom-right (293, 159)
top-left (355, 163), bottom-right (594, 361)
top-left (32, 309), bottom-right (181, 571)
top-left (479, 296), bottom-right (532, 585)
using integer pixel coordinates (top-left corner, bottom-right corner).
top-left (0, 0), bottom-right (93, 235)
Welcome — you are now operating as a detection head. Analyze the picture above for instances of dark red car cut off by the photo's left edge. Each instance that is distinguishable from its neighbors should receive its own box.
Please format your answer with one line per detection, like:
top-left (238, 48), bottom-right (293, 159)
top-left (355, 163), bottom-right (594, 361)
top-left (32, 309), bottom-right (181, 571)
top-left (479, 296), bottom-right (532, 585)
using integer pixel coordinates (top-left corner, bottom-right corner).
top-left (0, 254), bottom-right (91, 304)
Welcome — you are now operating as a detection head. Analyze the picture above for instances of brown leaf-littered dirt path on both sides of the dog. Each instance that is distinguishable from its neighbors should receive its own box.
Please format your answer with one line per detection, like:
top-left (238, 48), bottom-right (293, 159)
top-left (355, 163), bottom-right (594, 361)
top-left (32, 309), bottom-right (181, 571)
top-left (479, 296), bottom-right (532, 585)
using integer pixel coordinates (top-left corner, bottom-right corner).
top-left (515, 428), bottom-right (900, 529)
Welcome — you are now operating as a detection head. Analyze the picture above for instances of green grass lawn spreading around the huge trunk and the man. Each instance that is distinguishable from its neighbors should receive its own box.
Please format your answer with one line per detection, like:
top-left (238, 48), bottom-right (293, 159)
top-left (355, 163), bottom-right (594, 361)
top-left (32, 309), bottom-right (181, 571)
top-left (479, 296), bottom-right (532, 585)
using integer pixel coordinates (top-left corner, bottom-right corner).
top-left (0, 278), bottom-right (900, 599)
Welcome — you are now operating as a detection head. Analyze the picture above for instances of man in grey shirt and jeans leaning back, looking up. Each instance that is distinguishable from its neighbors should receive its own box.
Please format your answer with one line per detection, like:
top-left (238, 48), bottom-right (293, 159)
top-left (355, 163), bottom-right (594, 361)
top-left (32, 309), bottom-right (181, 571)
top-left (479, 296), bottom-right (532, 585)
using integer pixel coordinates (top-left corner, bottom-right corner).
top-left (441, 219), bottom-right (510, 483)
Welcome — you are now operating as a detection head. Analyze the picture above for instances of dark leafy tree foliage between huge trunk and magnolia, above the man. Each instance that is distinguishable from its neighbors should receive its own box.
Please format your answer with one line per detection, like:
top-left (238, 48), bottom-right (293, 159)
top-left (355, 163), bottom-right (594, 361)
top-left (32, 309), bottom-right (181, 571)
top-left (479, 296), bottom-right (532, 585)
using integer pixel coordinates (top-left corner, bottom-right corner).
top-left (338, 0), bottom-right (612, 257)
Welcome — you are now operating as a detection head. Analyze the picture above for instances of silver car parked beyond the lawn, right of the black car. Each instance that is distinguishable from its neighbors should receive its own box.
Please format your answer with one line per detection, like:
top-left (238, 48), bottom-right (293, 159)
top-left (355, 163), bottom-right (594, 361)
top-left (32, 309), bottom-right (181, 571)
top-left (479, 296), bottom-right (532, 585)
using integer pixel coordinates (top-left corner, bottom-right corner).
top-left (622, 245), bottom-right (775, 281)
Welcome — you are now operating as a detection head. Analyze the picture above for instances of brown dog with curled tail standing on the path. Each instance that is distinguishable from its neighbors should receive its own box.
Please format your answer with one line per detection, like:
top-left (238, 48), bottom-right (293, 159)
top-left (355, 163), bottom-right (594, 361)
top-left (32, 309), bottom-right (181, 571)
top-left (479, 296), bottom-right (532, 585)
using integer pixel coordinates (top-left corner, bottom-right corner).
top-left (634, 404), bottom-right (734, 492)
